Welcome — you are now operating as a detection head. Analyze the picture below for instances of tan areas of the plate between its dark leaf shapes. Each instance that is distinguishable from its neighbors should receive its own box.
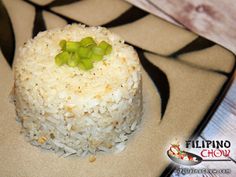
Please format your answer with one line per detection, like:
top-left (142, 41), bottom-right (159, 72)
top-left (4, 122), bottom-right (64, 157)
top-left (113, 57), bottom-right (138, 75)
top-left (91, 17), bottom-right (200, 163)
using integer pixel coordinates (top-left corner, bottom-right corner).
top-left (0, 0), bottom-right (235, 177)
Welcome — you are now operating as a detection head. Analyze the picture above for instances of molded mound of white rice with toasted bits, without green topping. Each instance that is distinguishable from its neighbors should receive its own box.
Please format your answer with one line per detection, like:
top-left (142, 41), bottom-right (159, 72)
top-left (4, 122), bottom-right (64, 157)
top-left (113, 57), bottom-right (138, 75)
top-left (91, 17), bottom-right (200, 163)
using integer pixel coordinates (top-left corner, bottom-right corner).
top-left (14, 24), bottom-right (142, 156)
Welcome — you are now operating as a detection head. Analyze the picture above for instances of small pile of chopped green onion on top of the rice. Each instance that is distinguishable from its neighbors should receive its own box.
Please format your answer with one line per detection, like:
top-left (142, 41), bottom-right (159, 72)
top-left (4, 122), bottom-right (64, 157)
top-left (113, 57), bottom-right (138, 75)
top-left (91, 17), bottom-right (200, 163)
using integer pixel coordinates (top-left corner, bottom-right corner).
top-left (55, 37), bottom-right (112, 70)
